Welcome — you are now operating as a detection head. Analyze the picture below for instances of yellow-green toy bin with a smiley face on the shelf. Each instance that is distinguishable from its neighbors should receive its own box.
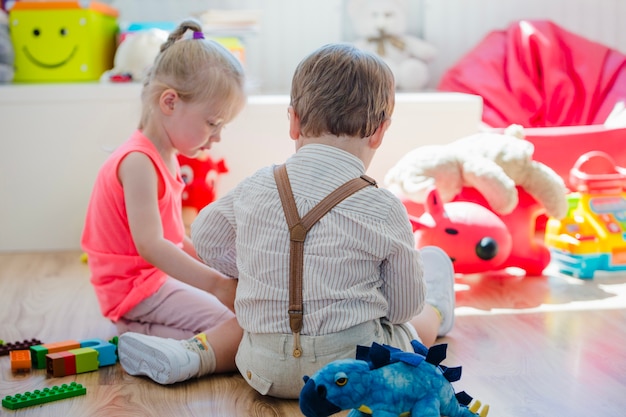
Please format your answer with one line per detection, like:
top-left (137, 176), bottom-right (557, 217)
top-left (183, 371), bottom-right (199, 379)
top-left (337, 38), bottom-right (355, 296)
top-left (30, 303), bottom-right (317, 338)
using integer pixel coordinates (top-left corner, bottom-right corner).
top-left (9, 1), bottom-right (118, 82)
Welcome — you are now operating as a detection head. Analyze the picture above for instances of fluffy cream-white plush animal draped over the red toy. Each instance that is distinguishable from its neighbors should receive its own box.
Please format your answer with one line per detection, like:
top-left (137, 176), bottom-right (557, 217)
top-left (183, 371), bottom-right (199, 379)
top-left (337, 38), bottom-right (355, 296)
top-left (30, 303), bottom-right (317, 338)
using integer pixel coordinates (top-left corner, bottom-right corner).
top-left (385, 125), bottom-right (567, 218)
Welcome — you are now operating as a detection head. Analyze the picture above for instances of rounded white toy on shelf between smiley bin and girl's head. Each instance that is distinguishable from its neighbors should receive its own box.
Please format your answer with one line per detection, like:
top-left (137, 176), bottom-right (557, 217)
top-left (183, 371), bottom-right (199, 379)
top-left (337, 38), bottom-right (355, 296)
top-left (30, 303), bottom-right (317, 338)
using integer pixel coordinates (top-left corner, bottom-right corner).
top-left (100, 28), bottom-right (169, 82)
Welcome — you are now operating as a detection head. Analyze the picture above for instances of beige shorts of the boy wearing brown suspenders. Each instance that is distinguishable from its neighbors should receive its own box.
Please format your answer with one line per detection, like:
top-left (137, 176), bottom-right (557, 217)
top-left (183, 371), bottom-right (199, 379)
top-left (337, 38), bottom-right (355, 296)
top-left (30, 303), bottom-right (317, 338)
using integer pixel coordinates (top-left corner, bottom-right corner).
top-left (235, 320), bottom-right (420, 399)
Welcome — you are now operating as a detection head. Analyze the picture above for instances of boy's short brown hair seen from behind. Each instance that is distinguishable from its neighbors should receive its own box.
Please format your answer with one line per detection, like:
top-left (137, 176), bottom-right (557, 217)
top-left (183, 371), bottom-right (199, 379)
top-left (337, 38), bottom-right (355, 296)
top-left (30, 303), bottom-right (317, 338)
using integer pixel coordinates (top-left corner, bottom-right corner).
top-left (291, 44), bottom-right (395, 138)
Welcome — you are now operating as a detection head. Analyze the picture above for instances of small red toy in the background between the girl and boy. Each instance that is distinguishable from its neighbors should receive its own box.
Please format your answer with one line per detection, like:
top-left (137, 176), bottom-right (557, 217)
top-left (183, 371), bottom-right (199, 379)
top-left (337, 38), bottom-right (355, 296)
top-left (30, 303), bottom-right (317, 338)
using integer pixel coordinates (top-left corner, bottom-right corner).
top-left (178, 151), bottom-right (228, 233)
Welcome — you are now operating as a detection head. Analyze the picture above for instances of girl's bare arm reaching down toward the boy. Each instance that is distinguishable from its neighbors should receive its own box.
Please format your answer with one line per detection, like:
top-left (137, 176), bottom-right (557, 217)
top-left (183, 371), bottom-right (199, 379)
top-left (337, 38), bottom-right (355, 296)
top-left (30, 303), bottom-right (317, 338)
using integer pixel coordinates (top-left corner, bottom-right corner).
top-left (118, 152), bottom-right (237, 310)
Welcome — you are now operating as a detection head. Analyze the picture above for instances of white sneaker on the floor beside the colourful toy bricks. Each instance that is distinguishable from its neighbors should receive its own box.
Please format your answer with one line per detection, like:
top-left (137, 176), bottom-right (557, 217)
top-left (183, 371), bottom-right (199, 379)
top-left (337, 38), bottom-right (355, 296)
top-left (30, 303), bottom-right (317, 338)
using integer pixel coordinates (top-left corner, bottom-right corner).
top-left (117, 332), bottom-right (200, 385)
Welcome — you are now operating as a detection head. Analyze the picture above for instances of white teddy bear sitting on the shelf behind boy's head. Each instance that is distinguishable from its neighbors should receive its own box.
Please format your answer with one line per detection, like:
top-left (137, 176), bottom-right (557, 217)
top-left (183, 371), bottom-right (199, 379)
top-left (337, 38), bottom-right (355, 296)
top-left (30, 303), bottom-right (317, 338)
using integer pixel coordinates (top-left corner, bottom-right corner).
top-left (347, 0), bottom-right (437, 91)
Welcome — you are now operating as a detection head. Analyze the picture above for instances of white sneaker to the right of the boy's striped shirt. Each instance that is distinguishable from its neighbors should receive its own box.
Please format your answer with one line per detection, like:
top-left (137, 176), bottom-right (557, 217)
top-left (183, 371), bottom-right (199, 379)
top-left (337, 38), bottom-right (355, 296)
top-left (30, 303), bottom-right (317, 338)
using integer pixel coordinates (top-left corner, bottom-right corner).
top-left (420, 246), bottom-right (456, 337)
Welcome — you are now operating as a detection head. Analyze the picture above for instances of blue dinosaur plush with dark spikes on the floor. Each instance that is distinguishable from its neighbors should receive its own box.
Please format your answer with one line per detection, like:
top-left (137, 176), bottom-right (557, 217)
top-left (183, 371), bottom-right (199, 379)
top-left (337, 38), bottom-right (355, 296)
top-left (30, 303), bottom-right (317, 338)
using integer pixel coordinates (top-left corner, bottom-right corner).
top-left (300, 340), bottom-right (489, 417)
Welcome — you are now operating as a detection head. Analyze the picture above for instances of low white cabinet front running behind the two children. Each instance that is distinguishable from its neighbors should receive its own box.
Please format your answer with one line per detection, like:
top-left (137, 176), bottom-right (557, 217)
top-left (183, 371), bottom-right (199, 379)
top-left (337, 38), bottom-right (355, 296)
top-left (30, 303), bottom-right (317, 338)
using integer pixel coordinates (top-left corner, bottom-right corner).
top-left (0, 84), bottom-right (482, 252)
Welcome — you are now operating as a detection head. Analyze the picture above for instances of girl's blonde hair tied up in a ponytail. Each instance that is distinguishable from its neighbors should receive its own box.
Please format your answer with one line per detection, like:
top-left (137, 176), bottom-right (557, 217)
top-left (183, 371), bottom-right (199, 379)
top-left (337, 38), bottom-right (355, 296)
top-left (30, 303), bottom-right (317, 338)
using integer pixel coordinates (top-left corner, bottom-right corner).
top-left (139, 19), bottom-right (245, 128)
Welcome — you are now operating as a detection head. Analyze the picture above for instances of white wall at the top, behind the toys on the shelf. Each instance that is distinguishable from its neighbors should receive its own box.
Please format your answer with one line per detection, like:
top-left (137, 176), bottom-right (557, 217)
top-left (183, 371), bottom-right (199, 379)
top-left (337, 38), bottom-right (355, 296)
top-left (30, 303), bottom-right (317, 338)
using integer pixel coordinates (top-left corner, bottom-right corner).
top-left (109, 0), bottom-right (626, 94)
